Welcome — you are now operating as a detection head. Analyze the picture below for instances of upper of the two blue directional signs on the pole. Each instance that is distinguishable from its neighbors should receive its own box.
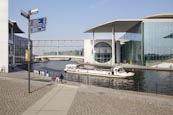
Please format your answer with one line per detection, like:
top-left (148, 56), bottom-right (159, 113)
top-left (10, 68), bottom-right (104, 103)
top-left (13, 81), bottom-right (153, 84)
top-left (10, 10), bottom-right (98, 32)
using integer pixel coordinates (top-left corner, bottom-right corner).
top-left (30, 17), bottom-right (46, 27)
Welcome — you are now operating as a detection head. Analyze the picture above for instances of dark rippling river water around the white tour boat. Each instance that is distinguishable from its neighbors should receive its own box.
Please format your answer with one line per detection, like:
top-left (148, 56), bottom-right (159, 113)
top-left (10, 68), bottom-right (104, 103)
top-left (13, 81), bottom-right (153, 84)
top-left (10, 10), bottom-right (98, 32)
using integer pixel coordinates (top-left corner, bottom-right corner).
top-left (32, 61), bottom-right (173, 95)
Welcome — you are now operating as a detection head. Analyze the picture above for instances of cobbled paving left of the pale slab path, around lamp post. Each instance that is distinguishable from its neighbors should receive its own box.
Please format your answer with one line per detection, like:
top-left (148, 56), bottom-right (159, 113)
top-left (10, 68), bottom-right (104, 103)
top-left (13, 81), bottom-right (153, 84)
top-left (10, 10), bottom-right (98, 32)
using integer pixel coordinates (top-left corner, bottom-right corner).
top-left (0, 71), bottom-right (54, 115)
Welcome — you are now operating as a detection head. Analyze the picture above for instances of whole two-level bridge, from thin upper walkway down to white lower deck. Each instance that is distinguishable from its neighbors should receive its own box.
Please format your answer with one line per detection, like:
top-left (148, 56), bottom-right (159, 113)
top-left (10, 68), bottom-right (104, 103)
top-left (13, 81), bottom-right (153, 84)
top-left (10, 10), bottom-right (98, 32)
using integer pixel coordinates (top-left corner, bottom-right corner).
top-left (32, 40), bottom-right (84, 62)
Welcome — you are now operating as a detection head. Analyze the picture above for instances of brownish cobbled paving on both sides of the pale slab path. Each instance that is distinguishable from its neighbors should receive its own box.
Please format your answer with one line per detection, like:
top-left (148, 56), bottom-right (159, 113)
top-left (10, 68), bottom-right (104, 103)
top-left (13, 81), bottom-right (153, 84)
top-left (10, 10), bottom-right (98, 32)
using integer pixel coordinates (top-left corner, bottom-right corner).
top-left (0, 67), bottom-right (173, 115)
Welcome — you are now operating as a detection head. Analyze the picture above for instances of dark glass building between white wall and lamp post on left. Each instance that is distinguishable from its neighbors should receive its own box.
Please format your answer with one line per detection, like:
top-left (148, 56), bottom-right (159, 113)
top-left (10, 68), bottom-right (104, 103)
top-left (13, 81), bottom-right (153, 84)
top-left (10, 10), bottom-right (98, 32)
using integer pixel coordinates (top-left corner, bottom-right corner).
top-left (8, 20), bottom-right (28, 71)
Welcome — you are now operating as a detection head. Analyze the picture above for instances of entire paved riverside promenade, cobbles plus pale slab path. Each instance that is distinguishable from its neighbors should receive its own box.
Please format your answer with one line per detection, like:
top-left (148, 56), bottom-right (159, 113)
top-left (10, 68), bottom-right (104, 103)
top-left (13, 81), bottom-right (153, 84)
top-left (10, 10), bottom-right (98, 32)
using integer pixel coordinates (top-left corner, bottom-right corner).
top-left (0, 68), bottom-right (173, 115)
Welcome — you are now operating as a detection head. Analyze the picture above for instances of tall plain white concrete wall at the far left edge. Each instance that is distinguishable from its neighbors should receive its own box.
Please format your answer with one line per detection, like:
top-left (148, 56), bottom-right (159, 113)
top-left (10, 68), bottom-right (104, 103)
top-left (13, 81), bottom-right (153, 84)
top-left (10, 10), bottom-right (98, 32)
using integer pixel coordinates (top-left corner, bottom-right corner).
top-left (0, 0), bottom-right (9, 72)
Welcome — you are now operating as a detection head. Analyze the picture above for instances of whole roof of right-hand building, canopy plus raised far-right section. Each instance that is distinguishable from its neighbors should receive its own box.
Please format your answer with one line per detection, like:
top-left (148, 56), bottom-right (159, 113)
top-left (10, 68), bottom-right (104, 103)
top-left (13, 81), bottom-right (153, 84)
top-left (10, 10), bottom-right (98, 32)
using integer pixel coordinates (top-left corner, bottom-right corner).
top-left (85, 14), bottom-right (173, 33)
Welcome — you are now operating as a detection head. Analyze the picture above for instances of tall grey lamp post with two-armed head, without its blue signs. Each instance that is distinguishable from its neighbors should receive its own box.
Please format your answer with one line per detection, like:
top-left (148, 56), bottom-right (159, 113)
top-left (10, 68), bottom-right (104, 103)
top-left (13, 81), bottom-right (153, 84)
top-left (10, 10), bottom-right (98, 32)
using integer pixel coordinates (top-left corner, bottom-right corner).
top-left (20, 9), bottom-right (38, 93)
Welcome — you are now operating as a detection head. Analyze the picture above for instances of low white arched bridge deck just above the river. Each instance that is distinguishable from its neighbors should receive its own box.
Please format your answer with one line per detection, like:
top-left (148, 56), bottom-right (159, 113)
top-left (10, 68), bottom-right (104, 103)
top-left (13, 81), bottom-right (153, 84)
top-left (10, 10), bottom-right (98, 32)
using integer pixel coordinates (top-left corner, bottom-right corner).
top-left (34, 55), bottom-right (84, 62)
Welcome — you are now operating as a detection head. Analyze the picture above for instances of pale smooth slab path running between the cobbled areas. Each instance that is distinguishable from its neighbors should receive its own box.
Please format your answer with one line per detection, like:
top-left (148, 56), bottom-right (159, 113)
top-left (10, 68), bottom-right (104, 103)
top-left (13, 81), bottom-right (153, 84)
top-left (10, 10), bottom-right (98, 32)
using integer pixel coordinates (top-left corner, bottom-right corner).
top-left (22, 84), bottom-right (78, 115)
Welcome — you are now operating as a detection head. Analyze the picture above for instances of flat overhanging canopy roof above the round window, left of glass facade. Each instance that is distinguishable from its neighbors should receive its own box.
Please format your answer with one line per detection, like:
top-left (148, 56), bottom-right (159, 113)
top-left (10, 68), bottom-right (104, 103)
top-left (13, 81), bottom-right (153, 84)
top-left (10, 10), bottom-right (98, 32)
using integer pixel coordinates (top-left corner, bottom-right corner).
top-left (85, 19), bottom-right (142, 32)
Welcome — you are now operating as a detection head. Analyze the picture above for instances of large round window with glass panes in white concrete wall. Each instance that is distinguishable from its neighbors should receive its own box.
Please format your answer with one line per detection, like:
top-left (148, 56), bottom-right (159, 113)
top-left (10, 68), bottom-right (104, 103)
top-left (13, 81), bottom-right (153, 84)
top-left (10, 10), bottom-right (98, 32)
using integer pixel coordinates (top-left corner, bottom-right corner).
top-left (94, 42), bottom-right (112, 63)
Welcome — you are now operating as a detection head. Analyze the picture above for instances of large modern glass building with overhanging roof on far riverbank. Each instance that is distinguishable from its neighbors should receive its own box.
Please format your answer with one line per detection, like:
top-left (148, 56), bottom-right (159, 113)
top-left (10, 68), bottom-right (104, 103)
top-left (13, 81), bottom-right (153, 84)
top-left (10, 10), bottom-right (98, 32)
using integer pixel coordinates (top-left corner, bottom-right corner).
top-left (86, 14), bottom-right (173, 66)
